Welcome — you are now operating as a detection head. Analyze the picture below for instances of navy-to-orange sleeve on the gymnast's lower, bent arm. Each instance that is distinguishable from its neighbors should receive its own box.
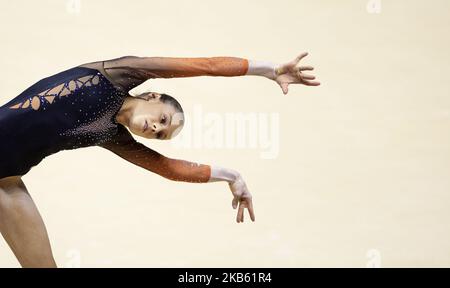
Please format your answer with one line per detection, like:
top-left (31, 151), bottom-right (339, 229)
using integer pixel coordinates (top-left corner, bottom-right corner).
top-left (99, 125), bottom-right (211, 183)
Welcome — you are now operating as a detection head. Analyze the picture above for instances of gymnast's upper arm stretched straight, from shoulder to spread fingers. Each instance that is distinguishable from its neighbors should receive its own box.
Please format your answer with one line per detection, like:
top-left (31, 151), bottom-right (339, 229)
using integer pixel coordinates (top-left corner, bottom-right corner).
top-left (103, 53), bottom-right (319, 94)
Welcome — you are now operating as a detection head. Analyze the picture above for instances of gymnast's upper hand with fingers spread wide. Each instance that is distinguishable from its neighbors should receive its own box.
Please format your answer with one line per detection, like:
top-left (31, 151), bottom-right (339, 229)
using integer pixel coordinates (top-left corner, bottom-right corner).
top-left (273, 52), bottom-right (320, 95)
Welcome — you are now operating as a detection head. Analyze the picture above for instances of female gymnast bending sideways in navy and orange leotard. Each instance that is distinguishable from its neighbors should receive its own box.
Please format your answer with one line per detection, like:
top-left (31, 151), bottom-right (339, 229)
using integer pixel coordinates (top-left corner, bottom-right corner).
top-left (0, 53), bottom-right (320, 267)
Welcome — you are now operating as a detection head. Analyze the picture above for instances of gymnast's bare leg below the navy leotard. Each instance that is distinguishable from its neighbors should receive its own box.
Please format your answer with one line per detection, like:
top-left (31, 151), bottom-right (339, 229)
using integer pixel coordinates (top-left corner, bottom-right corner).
top-left (0, 176), bottom-right (56, 267)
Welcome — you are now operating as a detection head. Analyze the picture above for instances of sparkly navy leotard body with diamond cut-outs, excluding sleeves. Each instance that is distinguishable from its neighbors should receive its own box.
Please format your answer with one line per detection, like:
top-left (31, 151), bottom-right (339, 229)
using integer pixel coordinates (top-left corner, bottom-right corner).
top-left (0, 67), bottom-right (127, 179)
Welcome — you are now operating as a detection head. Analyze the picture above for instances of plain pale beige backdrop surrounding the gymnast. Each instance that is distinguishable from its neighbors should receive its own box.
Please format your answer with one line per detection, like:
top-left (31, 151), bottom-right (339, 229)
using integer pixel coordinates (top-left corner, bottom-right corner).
top-left (0, 0), bottom-right (450, 267)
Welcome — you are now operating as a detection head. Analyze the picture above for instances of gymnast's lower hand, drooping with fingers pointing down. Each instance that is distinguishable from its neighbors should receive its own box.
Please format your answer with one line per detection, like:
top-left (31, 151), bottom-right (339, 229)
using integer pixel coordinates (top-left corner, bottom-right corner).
top-left (228, 175), bottom-right (255, 223)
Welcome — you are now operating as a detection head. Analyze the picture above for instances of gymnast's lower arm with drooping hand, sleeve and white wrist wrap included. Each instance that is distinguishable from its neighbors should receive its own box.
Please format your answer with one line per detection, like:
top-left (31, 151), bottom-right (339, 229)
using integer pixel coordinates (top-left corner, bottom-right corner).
top-left (99, 125), bottom-right (255, 222)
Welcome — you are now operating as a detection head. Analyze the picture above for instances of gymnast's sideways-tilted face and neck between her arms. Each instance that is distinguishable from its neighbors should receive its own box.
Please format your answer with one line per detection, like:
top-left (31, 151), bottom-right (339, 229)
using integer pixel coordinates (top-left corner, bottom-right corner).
top-left (125, 92), bottom-right (184, 140)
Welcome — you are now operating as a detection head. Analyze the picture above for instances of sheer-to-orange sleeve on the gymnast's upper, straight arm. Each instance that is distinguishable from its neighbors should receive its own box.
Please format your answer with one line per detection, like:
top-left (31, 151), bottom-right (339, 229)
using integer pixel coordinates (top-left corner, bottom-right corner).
top-left (104, 56), bottom-right (248, 89)
